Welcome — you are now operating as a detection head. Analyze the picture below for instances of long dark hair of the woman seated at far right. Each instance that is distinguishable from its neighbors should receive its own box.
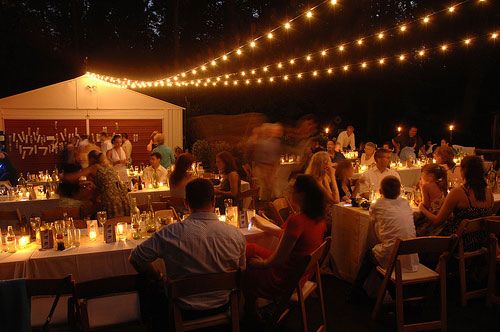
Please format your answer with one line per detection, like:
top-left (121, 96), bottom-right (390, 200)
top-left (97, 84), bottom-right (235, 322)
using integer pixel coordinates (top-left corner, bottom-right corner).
top-left (460, 156), bottom-right (487, 202)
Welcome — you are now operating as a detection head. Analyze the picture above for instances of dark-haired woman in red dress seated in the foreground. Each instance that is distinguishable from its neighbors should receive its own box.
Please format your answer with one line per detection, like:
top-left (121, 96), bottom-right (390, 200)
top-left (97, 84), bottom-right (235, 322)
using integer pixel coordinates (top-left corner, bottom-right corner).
top-left (243, 175), bottom-right (326, 317)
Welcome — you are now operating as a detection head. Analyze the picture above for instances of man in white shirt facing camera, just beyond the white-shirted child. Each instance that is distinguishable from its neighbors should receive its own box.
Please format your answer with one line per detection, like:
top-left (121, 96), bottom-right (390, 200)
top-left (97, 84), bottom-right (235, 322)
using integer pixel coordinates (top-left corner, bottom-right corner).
top-left (357, 149), bottom-right (401, 199)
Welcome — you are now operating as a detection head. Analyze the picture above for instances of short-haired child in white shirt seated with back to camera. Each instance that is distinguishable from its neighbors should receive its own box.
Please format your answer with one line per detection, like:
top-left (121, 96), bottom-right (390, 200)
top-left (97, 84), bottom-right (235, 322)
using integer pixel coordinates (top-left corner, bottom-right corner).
top-left (352, 176), bottom-right (419, 297)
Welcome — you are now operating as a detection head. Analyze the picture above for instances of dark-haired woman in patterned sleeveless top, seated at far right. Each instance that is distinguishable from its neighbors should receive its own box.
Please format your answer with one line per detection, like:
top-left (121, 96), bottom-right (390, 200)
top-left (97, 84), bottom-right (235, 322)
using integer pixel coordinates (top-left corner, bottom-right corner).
top-left (419, 156), bottom-right (494, 251)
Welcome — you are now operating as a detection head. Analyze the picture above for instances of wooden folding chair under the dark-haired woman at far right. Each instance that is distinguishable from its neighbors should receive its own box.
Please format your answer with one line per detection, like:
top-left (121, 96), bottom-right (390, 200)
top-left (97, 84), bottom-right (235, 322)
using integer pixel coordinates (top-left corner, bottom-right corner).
top-left (455, 218), bottom-right (488, 307)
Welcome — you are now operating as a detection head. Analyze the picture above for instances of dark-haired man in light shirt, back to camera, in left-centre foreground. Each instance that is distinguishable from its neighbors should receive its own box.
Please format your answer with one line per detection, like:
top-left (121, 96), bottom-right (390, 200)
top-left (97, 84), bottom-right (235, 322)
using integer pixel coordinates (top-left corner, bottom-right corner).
top-left (129, 179), bottom-right (246, 322)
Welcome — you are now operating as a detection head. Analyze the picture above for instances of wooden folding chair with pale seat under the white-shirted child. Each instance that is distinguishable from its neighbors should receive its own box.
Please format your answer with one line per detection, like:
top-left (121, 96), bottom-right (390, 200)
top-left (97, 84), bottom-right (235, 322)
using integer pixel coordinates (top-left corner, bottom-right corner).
top-left (372, 235), bottom-right (457, 331)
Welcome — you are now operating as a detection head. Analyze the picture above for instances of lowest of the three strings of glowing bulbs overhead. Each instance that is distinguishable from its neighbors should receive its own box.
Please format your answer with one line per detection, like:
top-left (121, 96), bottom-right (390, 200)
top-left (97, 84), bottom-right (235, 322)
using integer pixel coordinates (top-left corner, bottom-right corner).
top-left (148, 32), bottom-right (499, 88)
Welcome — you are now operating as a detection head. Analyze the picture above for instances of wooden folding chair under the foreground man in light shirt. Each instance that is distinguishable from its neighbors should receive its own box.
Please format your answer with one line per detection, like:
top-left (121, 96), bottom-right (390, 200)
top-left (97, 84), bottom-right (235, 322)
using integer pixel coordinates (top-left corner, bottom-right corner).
top-left (167, 271), bottom-right (240, 332)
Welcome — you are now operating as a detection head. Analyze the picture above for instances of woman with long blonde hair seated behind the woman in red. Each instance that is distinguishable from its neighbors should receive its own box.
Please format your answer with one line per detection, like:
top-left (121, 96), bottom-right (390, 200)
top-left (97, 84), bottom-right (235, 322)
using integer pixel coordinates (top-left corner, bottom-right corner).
top-left (306, 151), bottom-right (340, 224)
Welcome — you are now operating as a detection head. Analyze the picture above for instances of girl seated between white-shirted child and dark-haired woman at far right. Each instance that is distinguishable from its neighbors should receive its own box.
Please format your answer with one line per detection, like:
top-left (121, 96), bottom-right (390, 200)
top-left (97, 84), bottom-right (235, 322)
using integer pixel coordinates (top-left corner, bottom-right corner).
top-left (415, 164), bottom-right (448, 236)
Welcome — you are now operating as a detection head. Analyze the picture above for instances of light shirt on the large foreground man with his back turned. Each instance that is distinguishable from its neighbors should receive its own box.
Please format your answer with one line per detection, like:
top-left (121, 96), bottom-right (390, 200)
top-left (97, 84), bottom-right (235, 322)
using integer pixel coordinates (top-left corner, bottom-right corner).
top-left (131, 212), bottom-right (246, 310)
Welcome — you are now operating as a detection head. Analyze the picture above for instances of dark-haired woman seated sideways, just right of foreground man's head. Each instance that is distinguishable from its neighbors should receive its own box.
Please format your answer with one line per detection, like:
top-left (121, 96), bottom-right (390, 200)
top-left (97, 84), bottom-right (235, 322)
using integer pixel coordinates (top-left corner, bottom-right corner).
top-left (215, 151), bottom-right (241, 214)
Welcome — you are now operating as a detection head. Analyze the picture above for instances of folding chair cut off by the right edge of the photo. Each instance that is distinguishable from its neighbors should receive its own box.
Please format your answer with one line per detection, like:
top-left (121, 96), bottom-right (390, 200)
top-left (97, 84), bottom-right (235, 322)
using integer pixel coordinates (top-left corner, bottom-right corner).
top-left (485, 216), bottom-right (500, 307)
